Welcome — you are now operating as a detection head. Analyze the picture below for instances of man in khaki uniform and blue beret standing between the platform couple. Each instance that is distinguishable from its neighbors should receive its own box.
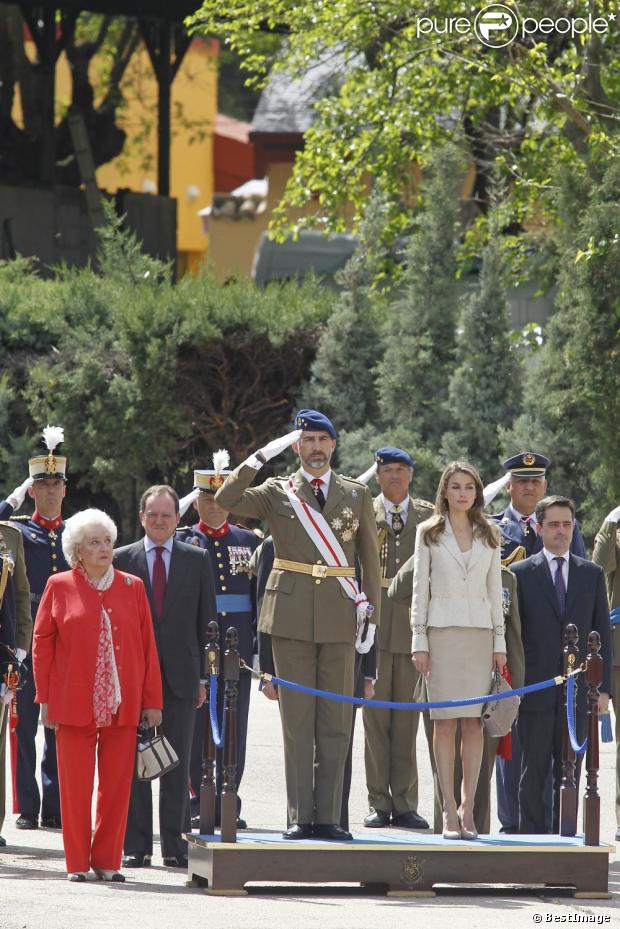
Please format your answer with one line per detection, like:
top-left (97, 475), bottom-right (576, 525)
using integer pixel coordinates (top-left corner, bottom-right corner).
top-left (364, 446), bottom-right (433, 829)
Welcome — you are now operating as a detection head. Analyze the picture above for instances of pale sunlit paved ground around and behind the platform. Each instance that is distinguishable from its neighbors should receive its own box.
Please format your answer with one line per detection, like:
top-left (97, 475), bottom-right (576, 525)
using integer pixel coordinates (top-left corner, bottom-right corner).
top-left (0, 693), bottom-right (620, 929)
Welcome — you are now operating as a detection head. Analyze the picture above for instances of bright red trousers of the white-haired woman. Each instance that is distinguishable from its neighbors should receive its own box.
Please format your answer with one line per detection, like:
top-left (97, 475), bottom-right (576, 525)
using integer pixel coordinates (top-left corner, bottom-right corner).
top-left (56, 722), bottom-right (136, 873)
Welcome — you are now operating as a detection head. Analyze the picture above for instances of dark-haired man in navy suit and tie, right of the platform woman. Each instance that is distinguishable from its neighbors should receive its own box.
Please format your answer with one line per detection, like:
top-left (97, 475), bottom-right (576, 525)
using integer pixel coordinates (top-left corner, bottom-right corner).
top-left (513, 496), bottom-right (612, 834)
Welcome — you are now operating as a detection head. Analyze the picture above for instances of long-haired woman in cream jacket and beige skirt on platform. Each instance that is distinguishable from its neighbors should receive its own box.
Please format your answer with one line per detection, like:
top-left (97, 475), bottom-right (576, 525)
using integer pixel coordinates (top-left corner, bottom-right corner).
top-left (411, 461), bottom-right (506, 839)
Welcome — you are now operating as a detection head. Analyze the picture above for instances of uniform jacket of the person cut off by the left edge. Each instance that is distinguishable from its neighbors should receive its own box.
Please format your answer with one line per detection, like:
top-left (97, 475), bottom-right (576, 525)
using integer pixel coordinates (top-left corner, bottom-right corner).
top-left (0, 523), bottom-right (32, 652)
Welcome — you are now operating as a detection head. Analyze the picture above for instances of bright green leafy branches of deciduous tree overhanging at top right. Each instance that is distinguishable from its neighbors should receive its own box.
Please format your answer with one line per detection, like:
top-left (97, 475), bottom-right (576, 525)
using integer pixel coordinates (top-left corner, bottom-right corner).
top-left (192, 0), bottom-right (620, 239)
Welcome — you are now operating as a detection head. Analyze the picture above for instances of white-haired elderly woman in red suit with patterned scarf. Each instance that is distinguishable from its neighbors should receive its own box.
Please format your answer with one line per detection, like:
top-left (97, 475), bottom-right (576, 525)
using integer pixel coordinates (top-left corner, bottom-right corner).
top-left (32, 509), bottom-right (163, 882)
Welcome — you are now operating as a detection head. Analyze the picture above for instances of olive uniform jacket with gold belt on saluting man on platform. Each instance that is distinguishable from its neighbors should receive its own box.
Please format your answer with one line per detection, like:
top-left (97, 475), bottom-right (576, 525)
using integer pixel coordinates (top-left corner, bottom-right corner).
top-left (215, 465), bottom-right (381, 644)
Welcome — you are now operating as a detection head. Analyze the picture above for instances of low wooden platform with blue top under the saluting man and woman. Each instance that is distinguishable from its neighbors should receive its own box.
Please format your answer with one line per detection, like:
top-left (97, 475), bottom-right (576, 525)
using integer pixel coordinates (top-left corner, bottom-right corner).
top-left (187, 831), bottom-right (614, 898)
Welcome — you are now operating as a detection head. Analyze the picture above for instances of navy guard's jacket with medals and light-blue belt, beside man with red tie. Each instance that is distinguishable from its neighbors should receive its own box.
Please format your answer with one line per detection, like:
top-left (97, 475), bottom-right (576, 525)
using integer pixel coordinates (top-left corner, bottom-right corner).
top-left (176, 523), bottom-right (260, 663)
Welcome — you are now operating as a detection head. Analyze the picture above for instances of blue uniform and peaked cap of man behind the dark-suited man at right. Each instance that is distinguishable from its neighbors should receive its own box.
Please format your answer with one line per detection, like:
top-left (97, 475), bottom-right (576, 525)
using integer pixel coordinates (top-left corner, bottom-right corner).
top-left (489, 452), bottom-right (586, 833)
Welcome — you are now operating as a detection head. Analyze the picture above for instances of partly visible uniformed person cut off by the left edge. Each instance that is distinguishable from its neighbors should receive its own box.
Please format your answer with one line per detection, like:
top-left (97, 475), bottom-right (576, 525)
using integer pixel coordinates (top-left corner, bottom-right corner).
top-left (0, 523), bottom-right (32, 848)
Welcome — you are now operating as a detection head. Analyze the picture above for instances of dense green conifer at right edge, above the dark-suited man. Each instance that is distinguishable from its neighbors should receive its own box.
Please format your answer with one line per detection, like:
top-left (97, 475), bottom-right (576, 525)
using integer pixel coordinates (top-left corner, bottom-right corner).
top-left (504, 161), bottom-right (620, 538)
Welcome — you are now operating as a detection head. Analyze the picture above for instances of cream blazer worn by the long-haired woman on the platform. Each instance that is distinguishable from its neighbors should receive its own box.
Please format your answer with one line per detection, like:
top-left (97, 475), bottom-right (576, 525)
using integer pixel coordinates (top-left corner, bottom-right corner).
top-left (411, 519), bottom-right (506, 652)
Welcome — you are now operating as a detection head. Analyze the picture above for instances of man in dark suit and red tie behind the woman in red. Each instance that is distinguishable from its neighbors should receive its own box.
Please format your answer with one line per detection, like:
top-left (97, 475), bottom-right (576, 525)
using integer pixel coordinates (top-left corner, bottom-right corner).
top-left (114, 484), bottom-right (217, 868)
